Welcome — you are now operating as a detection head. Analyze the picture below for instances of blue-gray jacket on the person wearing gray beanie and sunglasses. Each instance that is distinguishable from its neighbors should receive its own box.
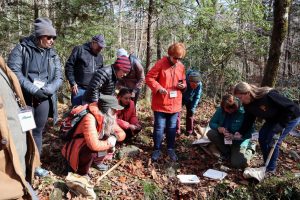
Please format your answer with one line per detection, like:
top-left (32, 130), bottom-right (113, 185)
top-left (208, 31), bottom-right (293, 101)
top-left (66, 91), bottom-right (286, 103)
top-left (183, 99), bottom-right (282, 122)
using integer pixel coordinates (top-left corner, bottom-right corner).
top-left (7, 36), bottom-right (63, 123)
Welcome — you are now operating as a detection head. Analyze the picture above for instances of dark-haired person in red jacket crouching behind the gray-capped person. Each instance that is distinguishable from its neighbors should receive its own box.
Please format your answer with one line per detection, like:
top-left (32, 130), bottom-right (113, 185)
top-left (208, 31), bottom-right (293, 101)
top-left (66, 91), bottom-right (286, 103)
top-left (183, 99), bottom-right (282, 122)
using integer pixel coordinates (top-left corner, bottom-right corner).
top-left (117, 88), bottom-right (142, 140)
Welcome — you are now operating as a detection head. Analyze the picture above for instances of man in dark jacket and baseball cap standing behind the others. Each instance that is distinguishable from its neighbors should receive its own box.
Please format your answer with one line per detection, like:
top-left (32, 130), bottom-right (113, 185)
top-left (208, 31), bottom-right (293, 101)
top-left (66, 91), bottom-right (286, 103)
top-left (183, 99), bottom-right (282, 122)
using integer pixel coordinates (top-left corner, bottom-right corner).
top-left (65, 35), bottom-right (105, 106)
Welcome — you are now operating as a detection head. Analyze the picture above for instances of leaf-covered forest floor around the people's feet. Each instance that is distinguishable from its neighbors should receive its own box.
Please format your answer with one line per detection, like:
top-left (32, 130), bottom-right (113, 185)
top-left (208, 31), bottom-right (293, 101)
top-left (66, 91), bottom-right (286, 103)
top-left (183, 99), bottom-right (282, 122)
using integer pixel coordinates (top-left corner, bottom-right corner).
top-left (34, 101), bottom-right (300, 200)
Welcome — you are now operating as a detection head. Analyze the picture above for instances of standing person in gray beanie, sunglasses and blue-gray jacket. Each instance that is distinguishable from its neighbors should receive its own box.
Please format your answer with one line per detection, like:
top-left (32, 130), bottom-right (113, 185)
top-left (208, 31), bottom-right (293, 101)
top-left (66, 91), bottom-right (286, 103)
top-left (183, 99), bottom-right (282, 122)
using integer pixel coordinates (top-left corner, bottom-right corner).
top-left (8, 18), bottom-right (63, 177)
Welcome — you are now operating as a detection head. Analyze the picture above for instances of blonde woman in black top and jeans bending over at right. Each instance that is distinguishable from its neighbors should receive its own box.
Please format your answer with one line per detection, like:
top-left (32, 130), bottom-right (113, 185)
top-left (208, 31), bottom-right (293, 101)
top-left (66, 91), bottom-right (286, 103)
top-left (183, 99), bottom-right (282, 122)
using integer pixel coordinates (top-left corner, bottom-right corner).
top-left (234, 82), bottom-right (300, 173)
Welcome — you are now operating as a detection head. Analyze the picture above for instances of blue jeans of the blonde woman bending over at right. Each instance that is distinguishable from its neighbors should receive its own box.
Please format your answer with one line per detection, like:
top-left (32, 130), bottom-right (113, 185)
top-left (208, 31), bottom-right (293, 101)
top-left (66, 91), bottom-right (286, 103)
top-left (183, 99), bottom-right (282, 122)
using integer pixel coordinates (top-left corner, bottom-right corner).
top-left (259, 117), bottom-right (300, 171)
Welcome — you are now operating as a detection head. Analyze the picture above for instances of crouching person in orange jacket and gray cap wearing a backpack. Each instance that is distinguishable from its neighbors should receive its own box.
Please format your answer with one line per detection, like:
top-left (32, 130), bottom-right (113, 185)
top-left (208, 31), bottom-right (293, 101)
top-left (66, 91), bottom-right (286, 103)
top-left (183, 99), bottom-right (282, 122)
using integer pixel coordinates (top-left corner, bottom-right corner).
top-left (62, 95), bottom-right (126, 176)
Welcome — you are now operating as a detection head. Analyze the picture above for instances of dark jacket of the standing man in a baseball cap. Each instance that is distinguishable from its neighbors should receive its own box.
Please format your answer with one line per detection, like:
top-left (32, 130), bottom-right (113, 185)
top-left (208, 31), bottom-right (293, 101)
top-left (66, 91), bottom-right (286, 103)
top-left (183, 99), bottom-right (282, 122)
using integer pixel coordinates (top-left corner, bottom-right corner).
top-left (65, 42), bottom-right (103, 89)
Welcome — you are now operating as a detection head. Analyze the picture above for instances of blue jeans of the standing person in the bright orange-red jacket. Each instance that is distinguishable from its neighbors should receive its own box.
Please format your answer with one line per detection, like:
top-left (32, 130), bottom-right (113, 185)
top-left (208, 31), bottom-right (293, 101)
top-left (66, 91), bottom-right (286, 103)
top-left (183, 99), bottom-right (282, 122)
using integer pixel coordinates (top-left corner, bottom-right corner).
top-left (153, 111), bottom-right (178, 150)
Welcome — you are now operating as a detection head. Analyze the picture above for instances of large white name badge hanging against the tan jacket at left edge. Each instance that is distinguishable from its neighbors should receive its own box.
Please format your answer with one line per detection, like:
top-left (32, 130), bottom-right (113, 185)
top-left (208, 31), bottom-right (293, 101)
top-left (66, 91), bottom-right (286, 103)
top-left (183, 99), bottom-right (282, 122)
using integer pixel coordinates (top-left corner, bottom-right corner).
top-left (18, 107), bottom-right (36, 132)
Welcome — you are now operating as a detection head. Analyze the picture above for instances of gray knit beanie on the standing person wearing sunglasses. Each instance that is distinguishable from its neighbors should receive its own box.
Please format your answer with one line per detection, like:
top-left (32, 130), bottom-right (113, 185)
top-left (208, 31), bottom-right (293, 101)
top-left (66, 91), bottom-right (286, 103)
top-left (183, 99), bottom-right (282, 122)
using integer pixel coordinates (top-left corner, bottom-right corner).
top-left (34, 17), bottom-right (56, 37)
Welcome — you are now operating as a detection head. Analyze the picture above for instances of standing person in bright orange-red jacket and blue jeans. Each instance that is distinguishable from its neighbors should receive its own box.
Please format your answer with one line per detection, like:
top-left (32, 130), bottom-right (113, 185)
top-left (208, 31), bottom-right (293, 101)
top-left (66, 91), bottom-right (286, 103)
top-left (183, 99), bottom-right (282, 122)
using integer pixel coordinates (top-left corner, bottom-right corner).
top-left (146, 43), bottom-right (186, 161)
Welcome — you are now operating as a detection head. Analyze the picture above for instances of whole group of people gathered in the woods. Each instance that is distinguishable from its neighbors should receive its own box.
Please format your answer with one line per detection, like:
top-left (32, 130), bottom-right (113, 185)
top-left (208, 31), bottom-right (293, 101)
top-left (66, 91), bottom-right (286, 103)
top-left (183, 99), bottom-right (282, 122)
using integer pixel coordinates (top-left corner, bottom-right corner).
top-left (0, 18), bottom-right (300, 199)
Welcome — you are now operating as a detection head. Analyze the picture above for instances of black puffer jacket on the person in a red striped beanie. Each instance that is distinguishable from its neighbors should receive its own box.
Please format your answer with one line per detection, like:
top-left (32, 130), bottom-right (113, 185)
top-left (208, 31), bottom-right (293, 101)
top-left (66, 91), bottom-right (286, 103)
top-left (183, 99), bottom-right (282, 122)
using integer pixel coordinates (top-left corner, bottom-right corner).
top-left (84, 65), bottom-right (117, 103)
